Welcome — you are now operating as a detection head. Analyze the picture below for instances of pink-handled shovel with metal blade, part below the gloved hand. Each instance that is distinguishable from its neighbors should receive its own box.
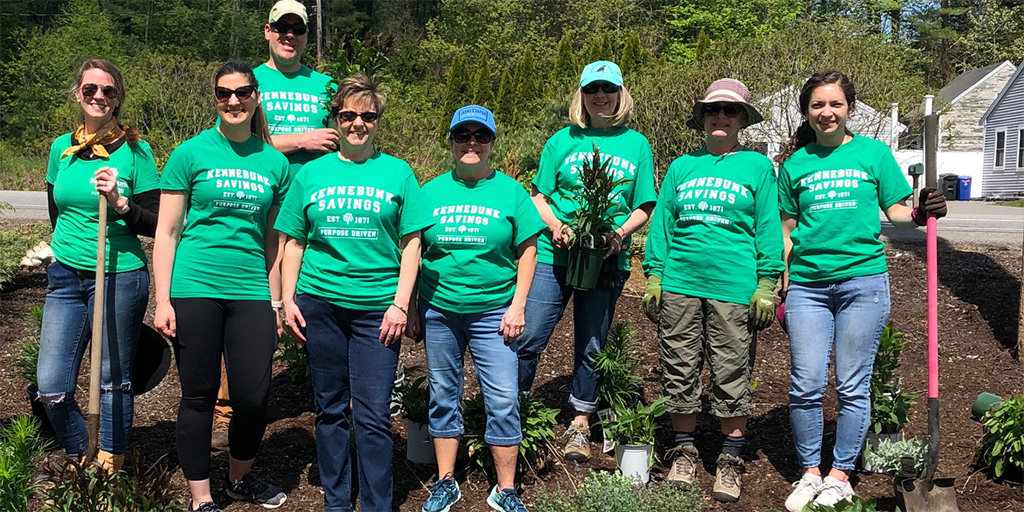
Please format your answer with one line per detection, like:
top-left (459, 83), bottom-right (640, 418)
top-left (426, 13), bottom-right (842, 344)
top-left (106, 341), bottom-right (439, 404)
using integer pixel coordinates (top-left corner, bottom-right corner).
top-left (896, 217), bottom-right (959, 512)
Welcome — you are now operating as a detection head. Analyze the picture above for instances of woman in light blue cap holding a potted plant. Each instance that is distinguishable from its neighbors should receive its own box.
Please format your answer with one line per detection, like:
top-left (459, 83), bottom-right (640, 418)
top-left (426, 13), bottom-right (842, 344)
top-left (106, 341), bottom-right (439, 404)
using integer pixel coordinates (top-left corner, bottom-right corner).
top-left (517, 60), bottom-right (657, 462)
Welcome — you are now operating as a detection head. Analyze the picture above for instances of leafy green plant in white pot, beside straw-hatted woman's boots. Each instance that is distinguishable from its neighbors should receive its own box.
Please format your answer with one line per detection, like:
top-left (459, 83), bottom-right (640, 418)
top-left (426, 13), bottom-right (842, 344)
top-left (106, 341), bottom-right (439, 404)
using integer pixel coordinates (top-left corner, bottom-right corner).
top-left (602, 396), bottom-right (669, 483)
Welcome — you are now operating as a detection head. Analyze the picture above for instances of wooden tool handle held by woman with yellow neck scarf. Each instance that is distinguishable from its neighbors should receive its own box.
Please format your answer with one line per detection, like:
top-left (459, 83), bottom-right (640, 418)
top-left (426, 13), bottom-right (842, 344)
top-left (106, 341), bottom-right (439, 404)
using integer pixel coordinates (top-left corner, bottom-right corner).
top-left (86, 194), bottom-right (106, 462)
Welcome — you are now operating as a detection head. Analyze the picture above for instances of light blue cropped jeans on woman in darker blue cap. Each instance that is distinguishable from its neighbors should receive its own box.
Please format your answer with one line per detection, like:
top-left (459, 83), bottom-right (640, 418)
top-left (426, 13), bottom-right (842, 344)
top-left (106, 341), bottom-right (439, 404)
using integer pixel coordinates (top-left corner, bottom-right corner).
top-left (420, 300), bottom-right (522, 446)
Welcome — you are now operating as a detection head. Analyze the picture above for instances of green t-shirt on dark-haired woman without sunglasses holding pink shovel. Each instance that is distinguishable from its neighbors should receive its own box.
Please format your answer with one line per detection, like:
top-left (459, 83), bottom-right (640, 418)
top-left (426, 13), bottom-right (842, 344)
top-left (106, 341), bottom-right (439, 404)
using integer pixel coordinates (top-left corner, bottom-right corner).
top-left (778, 135), bottom-right (913, 283)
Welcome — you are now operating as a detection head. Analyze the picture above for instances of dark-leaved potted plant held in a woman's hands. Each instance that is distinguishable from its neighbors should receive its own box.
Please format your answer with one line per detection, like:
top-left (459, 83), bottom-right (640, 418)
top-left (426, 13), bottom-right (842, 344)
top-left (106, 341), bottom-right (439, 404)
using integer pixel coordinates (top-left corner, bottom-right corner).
top-left (565, 144), bottom-right (630, 290)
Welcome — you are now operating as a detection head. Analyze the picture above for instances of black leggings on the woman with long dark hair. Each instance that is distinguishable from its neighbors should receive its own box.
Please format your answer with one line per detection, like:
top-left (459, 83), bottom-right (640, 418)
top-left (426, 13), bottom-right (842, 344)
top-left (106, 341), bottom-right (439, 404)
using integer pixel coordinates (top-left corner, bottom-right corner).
top-left (171, 299), bottom-right (278, 480)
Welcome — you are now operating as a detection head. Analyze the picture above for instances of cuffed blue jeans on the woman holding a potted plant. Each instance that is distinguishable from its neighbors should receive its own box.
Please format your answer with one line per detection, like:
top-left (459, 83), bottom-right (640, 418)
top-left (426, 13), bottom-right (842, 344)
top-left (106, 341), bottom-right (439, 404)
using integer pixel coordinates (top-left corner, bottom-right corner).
top-left (515, 263), bottom-right (630, 413)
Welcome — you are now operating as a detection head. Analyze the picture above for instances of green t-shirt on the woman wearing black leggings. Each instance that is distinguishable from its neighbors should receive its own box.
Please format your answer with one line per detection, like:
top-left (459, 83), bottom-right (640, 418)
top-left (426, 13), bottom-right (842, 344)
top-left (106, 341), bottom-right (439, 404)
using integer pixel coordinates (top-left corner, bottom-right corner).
top-left (161, 128), bottom-right (290, 300)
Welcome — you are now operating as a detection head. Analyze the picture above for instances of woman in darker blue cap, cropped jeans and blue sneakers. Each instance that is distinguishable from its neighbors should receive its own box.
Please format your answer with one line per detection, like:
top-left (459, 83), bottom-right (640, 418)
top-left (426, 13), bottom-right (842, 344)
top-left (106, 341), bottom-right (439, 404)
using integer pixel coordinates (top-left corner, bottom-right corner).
top-left (410, 104), bottom-right (544, 512)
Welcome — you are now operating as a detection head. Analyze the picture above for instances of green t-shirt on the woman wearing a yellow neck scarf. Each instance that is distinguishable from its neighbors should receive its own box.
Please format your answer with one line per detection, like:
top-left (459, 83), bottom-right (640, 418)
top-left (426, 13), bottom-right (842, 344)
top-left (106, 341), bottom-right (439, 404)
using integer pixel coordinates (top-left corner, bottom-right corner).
top-left (46, 133), bottom-right (160, 272)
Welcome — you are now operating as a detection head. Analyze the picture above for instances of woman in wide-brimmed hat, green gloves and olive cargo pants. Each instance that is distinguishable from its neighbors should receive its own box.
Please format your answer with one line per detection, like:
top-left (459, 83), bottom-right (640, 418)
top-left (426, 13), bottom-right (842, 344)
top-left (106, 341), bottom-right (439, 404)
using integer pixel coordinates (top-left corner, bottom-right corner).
top-left (642, 78), bottom-right (782, 502)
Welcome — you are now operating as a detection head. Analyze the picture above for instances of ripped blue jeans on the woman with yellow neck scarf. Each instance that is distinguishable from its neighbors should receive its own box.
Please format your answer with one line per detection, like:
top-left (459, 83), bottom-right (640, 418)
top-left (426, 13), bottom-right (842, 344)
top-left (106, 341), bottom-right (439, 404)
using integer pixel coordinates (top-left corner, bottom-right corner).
top-left (37, 261), bottom-right (150, 458)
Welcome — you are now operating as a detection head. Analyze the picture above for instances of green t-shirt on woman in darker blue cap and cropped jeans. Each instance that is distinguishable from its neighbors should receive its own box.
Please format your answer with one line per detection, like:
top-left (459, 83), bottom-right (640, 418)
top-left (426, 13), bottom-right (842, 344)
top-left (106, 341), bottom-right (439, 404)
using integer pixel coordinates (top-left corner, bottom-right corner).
top-left (417, 171), bottom-right (544, 313)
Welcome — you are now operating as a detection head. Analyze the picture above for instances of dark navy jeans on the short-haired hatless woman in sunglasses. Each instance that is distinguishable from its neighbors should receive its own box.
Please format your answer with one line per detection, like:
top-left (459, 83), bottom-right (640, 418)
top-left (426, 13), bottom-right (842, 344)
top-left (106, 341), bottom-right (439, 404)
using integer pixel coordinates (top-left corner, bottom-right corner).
top-left (295, 294), bottom-right (401, 512)
